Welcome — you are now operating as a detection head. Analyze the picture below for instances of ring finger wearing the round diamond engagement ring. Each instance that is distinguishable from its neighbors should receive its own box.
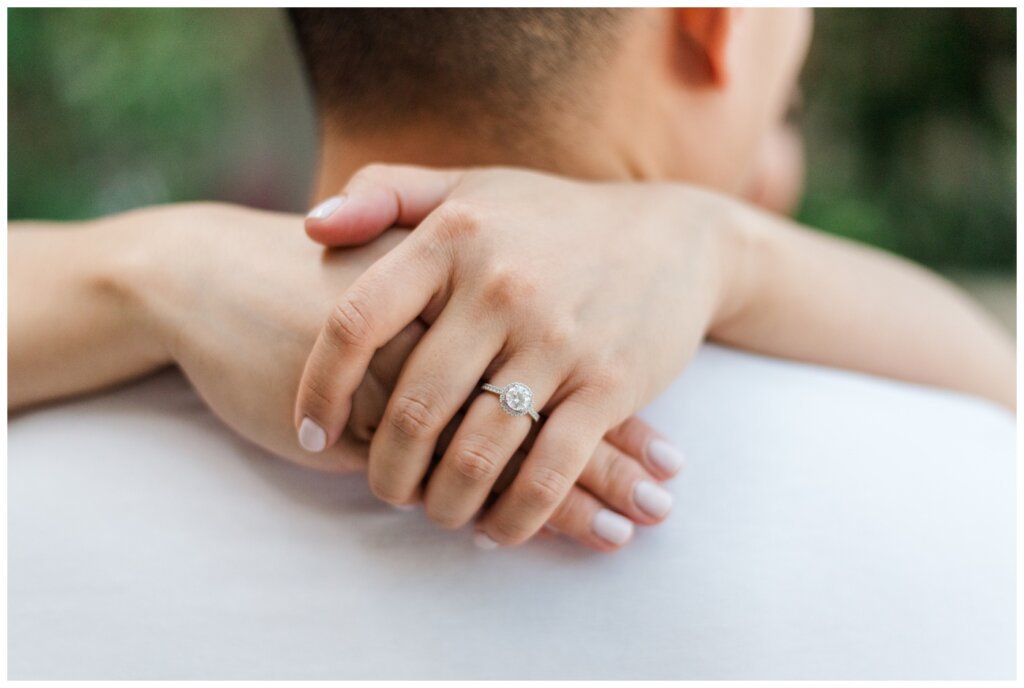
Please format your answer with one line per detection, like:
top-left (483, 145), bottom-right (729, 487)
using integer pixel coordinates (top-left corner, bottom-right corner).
top-left (424, 358), bottom-right (560, 528)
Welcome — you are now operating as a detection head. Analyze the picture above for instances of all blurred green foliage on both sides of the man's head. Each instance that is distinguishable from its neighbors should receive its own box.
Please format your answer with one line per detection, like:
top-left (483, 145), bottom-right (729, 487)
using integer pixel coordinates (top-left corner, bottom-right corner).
top-left (7, 8), bottom-right (1017, 270)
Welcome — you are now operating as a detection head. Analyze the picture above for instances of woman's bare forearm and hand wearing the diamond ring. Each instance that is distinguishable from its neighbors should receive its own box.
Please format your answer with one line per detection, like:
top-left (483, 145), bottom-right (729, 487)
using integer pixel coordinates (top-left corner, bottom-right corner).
top-left (295, 166), bottom-right (1013, 545)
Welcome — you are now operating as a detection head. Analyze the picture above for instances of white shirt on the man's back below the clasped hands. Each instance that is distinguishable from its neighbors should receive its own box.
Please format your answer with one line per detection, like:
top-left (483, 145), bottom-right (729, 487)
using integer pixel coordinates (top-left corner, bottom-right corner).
top-left (8, 346), bottom-right (1016, 679)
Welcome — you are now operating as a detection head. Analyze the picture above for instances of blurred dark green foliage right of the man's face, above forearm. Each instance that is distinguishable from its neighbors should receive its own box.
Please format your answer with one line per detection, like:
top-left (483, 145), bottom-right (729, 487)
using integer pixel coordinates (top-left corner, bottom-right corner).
top-left (799, 8), bottom-right (1017, 270)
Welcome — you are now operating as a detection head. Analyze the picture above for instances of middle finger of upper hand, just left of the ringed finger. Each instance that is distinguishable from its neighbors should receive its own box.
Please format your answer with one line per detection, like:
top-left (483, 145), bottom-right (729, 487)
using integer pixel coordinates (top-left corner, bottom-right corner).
top-left (369, 307), bottom-right (501, 504)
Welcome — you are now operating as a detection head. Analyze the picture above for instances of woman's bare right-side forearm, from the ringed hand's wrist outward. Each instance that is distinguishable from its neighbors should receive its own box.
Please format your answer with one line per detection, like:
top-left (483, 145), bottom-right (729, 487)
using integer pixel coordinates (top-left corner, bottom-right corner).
top-left (710, 201), bottom-right (1016, 409)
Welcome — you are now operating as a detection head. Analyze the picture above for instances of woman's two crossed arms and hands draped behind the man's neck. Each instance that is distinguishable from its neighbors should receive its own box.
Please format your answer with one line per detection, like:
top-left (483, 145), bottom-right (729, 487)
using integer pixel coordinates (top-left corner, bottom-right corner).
top-left (8, 167), bottom-right (1014, 550)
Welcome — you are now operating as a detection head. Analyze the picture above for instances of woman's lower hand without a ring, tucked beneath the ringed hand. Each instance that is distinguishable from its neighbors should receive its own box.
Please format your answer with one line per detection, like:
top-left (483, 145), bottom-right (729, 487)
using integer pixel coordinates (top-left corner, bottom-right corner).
top-left (105, 204), bottom-right (681, 551)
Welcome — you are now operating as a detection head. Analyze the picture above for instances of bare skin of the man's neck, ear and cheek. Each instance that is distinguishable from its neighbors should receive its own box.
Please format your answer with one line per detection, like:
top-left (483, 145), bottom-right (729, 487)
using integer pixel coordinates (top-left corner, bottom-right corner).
top-left (312, 7), bottom-right (812, 196)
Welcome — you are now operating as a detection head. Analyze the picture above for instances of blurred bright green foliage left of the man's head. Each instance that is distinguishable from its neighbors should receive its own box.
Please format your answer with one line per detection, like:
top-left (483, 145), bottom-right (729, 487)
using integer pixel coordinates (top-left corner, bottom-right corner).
top-left (7, 9), bottom-right (314, 219)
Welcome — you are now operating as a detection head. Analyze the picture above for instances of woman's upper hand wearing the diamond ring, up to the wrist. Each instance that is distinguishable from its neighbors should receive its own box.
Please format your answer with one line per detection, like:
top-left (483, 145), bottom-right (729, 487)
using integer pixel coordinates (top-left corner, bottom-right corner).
top-left (295, 166), bottom-right (728, 545)
